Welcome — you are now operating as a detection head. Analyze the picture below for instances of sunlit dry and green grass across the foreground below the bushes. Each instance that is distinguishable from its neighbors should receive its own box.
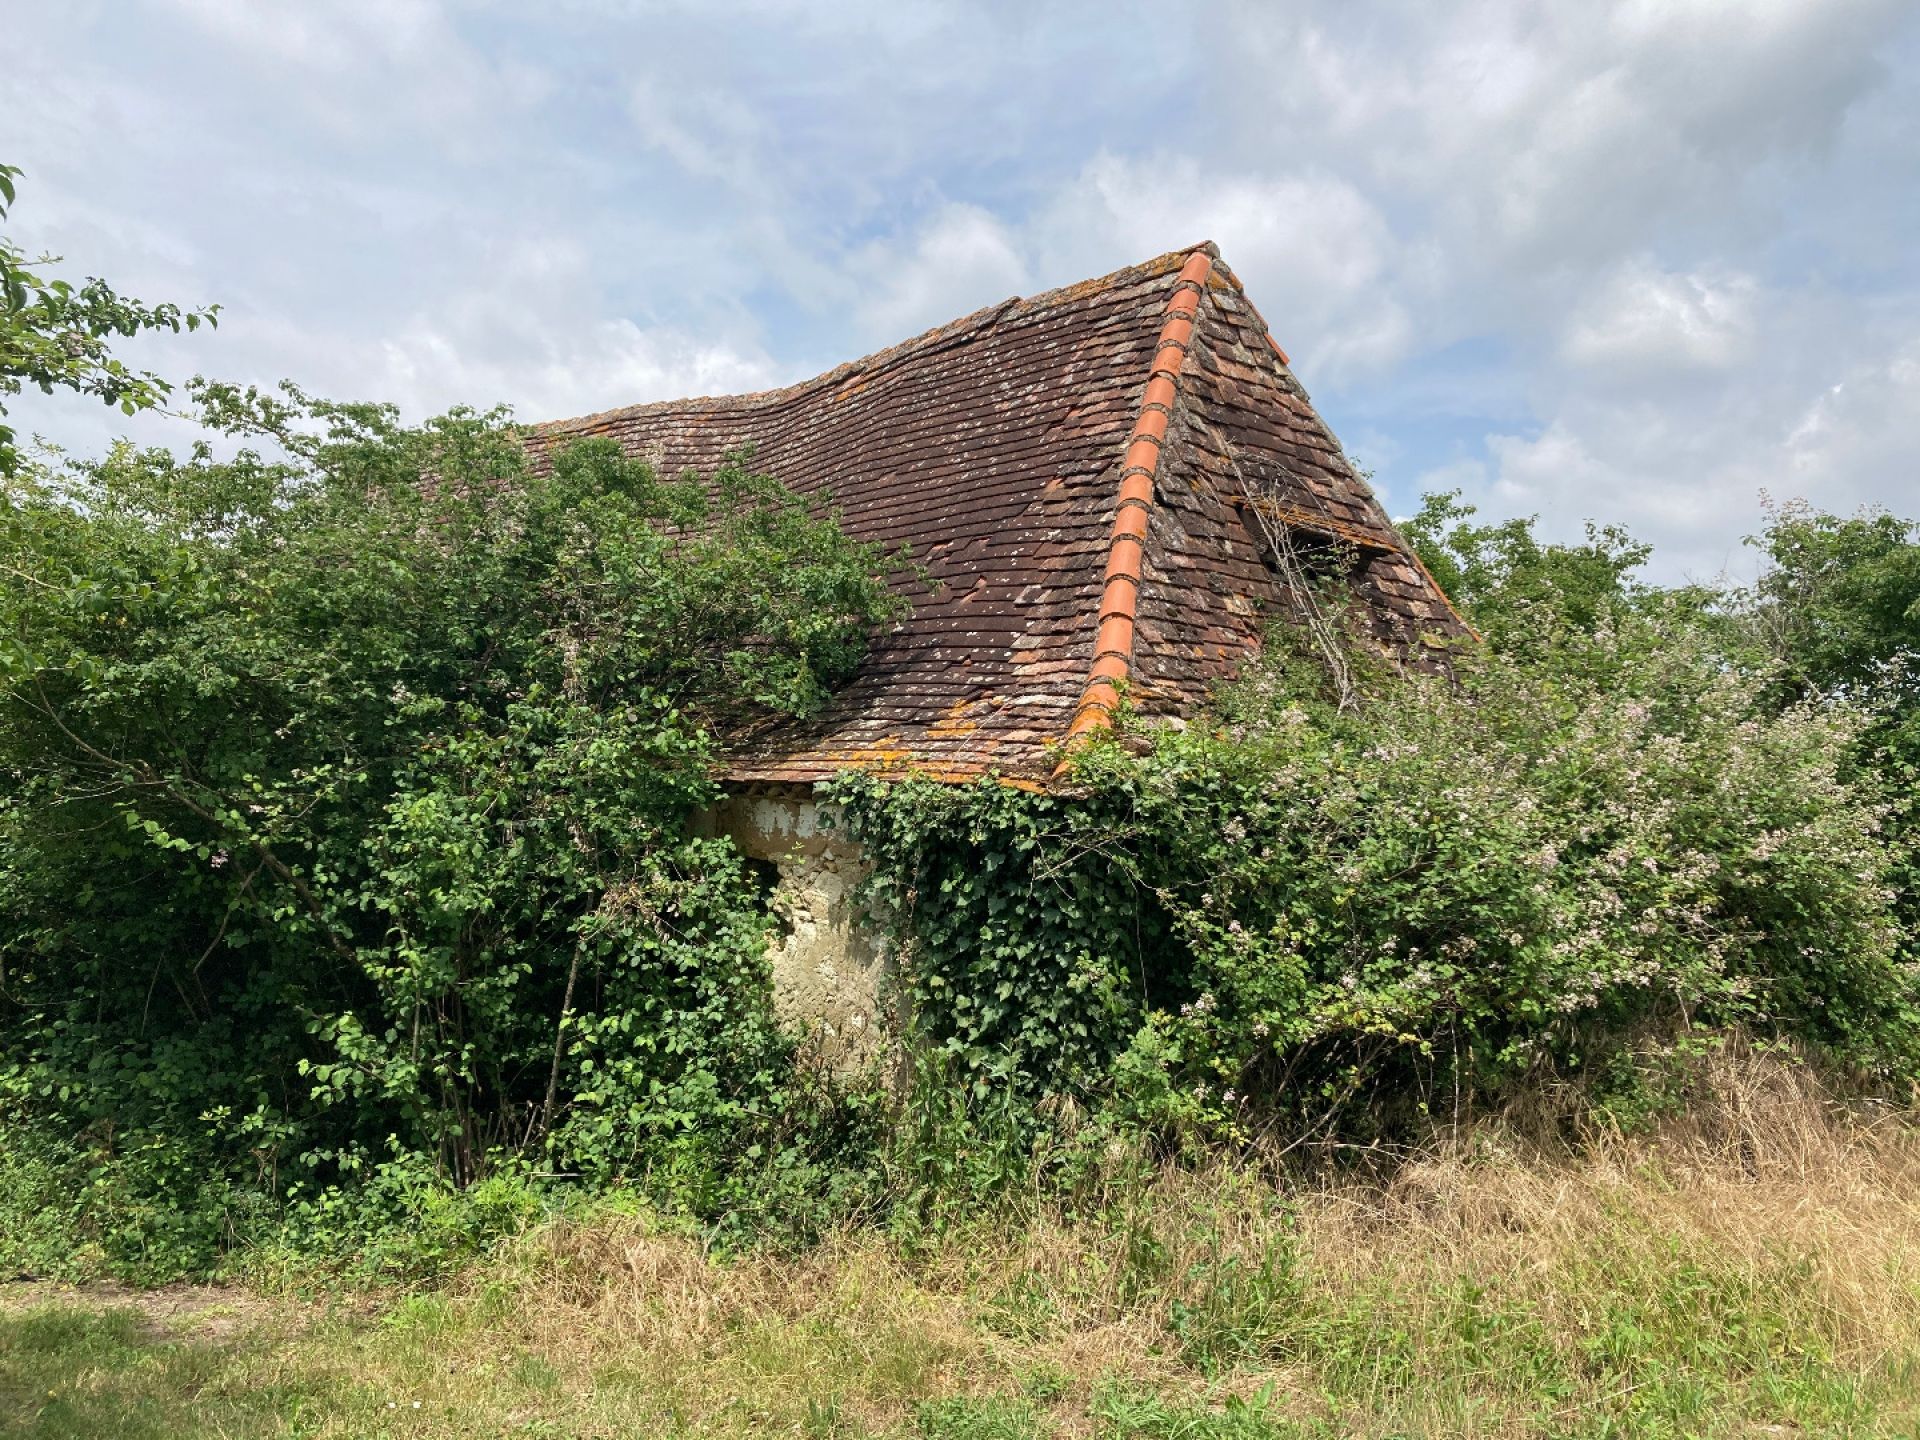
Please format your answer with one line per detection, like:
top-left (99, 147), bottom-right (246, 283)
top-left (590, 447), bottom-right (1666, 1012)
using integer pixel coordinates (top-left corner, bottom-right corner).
top-left (11, 1052), bottom-right (1920, 1440)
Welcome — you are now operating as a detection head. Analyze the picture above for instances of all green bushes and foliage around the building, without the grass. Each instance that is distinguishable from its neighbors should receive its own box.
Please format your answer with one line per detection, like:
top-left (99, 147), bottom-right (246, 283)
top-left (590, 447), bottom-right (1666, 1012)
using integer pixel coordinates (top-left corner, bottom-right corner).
top-left (0, 152), bottom-right (1920, 1275)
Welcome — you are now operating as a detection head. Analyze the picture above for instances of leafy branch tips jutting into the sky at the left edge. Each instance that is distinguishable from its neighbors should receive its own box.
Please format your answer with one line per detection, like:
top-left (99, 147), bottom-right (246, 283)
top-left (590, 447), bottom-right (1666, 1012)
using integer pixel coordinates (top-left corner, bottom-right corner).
top-left (0, 165), bottom-right (219, 474)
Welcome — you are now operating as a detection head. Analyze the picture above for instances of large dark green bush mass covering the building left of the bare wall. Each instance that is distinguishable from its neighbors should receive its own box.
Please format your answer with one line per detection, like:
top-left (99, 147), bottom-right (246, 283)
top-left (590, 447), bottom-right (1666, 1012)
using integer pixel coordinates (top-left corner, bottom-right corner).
top-left (0, 388), bottom-right (895, 1274)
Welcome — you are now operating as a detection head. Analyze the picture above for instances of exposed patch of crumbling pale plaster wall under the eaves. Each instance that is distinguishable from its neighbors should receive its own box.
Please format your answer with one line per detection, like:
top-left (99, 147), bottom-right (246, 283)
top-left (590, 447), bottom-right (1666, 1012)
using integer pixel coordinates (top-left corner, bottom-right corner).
top-left (699, 785), bottom-right (899, 1069)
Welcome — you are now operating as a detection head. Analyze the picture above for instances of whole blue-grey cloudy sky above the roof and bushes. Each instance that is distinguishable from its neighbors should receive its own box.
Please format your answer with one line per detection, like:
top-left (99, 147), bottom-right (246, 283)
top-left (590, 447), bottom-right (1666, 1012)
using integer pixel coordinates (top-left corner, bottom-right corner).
top-left (0, 0), bottom-right (1920, 578)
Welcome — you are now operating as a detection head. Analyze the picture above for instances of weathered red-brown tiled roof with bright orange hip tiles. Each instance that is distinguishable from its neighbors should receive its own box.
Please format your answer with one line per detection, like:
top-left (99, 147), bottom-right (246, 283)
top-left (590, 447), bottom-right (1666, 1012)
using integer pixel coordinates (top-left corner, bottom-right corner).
top-left (540, 244), bottom-right (1463, 781)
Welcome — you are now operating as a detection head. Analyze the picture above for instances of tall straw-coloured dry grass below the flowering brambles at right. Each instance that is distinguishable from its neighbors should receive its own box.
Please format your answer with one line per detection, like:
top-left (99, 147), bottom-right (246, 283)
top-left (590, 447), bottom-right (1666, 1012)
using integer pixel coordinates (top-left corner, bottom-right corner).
top-left (1344, 1052), bottom-right (1920, 1361)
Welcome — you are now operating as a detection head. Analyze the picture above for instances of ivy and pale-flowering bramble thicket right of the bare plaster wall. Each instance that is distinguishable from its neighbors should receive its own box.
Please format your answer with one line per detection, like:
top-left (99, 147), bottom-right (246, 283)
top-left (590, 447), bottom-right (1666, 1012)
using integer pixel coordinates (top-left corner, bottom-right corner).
top-left (839, 507), bottom-right (1920, 1140)
